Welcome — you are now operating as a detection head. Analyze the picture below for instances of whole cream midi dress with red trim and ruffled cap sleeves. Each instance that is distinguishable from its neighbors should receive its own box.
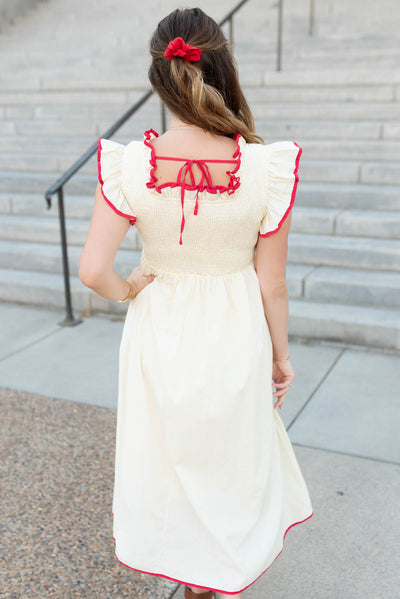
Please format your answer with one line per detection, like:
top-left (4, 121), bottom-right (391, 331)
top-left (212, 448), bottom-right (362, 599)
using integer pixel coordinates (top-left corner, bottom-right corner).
top-left (98, 129), bottom-right (313, 593)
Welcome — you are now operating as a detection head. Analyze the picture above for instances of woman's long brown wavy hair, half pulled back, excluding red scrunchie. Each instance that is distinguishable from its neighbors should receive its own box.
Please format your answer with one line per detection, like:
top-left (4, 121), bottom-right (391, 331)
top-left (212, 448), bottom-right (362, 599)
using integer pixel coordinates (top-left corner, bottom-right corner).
top-left (148, 8), bottom-right (263, 143)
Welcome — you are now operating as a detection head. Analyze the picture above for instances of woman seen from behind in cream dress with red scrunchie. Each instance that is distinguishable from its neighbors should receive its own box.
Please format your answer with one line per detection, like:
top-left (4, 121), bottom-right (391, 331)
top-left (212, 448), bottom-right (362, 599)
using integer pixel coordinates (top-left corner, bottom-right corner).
top-left (79, 8), bottom-right (312, 599)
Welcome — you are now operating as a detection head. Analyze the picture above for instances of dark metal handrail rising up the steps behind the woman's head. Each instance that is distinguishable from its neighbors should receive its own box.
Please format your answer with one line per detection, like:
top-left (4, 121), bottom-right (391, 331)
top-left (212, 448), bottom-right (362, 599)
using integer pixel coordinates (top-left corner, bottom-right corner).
top-left (45, 0), bottom-right (248, 326)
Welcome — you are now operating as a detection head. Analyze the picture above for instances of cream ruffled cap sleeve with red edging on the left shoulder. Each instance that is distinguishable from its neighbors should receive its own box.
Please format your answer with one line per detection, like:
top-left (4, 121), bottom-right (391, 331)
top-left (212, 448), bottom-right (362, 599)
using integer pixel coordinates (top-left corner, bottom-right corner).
top-left (97, 139), bottom-right (136, 225)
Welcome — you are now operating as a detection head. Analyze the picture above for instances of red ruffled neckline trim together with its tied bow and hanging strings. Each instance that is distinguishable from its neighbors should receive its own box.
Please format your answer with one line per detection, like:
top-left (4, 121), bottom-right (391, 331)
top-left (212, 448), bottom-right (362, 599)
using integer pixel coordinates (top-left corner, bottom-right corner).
top-left (144, 129), bottom-right (242, 245)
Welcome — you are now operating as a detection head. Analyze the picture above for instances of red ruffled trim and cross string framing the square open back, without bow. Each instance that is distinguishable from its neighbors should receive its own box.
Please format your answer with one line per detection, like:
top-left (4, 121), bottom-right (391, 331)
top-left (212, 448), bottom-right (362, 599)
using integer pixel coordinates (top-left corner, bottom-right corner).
top-left (144, 129), bottom-right (242, 194)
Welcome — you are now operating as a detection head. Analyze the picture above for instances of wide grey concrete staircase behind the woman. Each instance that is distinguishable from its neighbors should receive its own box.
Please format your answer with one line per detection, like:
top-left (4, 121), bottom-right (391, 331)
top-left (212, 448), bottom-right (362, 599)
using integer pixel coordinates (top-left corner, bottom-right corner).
top-left (0, 0), bottom-right (400, 349)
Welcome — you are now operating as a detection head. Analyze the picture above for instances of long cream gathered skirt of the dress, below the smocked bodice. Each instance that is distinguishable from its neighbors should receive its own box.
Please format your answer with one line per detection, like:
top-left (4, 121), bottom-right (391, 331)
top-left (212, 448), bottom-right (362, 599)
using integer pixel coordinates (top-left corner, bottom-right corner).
top-left (113, 263), bottom-right (312, 593)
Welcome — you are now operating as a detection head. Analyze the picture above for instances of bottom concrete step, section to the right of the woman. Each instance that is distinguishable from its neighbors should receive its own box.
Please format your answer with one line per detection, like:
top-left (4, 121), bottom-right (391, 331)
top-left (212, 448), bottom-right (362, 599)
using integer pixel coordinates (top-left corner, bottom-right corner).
top-left (289, 299), bottom-right (400, 349)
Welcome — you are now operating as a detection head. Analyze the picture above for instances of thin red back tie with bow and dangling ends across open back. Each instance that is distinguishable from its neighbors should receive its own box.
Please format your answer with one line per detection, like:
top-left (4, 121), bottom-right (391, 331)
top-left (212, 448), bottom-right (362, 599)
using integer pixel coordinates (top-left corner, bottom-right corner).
top-left (154, 156), bottom-right (237, 245)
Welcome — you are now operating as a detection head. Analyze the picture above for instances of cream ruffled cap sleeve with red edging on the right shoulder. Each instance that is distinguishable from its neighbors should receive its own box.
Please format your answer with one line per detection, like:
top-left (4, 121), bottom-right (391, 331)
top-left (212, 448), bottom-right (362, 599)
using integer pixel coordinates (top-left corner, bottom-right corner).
top-left (259, 141), bottom-right (303, 237)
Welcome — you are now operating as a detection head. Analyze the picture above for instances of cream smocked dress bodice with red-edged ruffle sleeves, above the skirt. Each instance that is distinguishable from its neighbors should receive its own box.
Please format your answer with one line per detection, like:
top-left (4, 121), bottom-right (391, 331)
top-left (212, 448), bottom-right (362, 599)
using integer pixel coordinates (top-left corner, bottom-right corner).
top-left (98, 130), bottom-right (302, 275)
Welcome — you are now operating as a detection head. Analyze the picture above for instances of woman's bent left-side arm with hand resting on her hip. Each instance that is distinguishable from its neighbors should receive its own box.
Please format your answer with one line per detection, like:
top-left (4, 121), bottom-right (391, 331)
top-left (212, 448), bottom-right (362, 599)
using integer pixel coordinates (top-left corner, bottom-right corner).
top-left (79, 183), bottom-right (154, 300)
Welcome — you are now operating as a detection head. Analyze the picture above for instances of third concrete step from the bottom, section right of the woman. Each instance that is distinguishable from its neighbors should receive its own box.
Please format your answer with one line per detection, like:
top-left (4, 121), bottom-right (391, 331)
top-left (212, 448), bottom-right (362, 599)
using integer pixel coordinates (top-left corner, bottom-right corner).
top-left (288, 233), bottom-right (400, 272)
